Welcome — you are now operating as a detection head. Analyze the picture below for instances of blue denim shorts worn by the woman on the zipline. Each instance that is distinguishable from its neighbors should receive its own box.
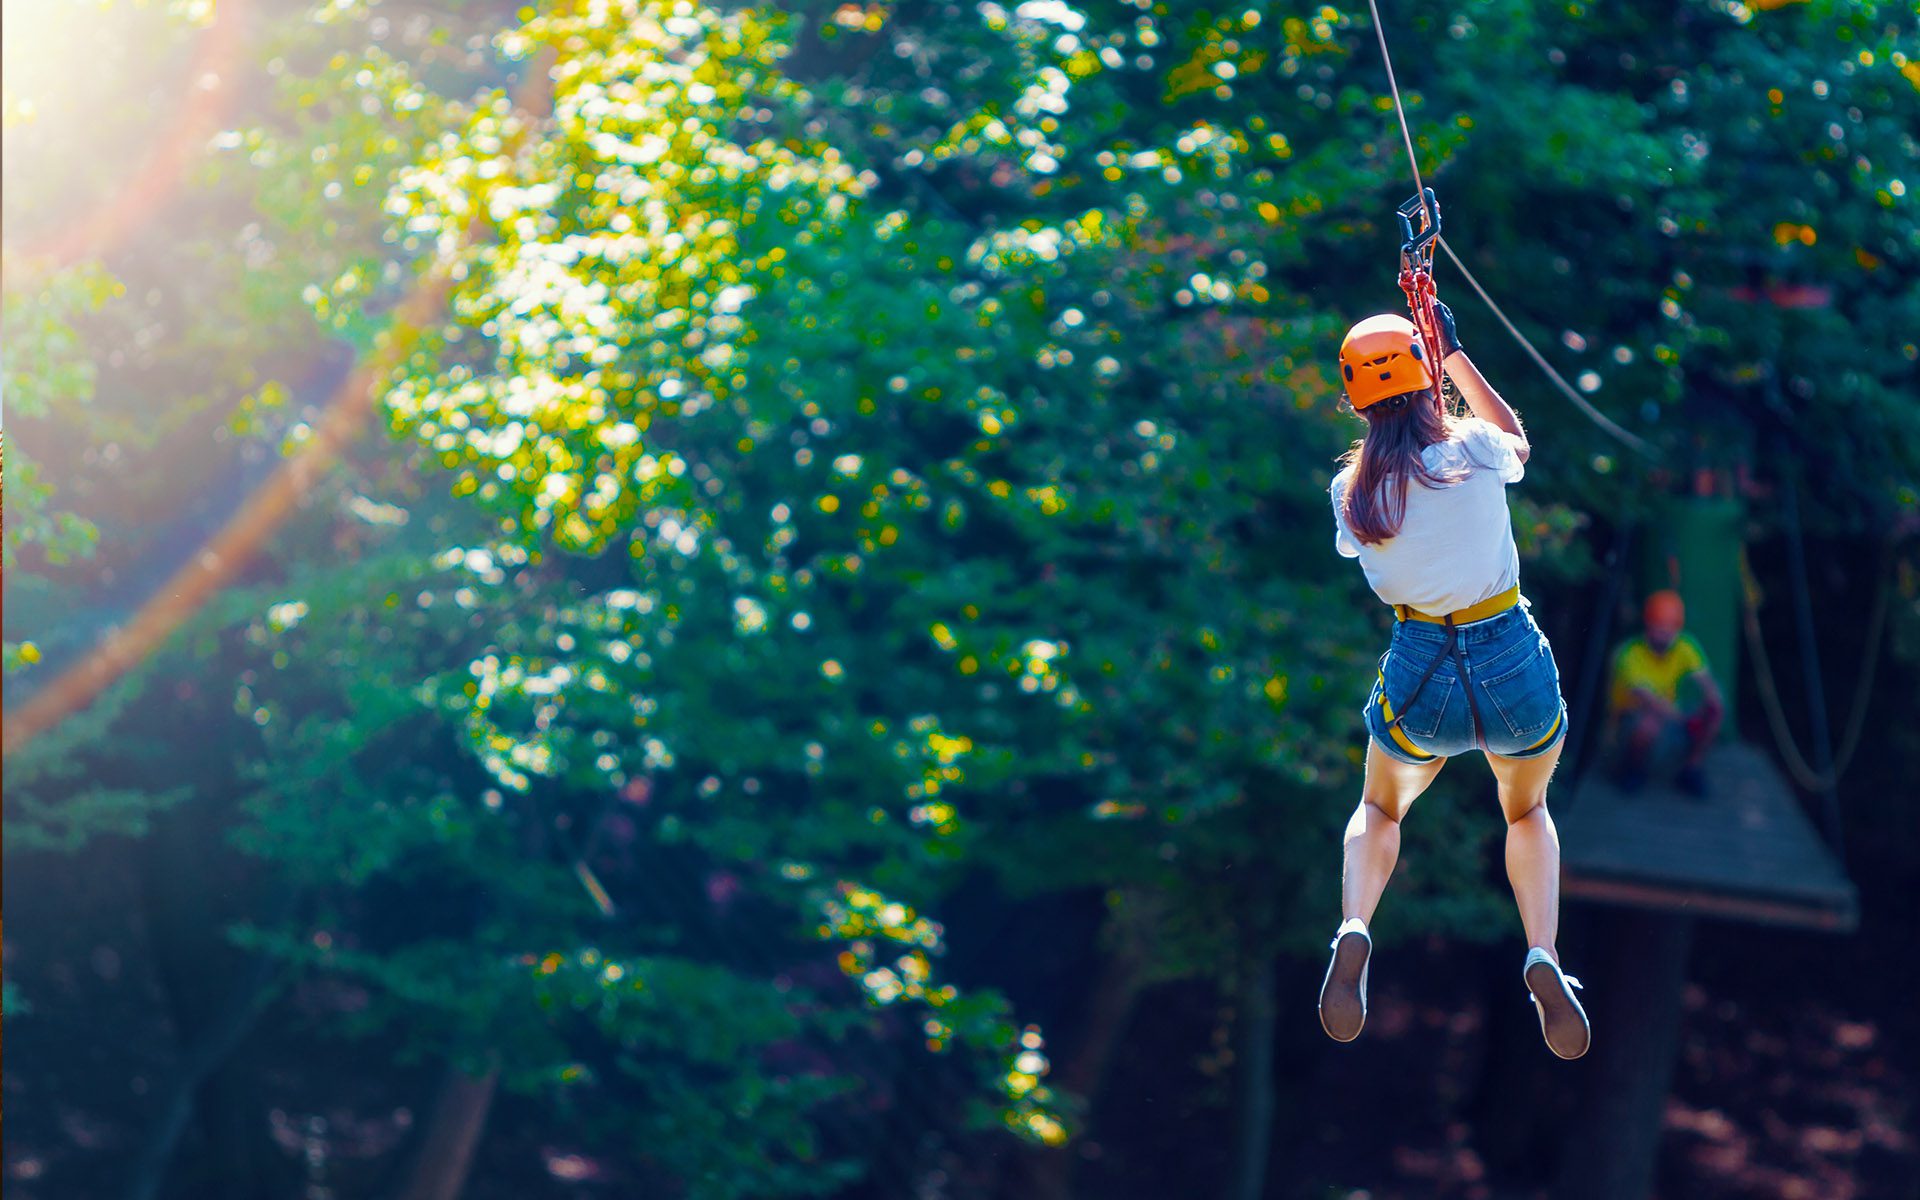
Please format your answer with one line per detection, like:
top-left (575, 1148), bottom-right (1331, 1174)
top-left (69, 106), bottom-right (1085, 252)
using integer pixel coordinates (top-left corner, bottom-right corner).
top-left (1367, 599), bottom-right (1567, 764)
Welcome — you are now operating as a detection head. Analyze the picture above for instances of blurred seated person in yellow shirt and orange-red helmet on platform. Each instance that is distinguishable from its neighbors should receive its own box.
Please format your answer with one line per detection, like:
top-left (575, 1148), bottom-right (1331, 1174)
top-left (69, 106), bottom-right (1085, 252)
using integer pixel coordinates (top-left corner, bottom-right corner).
top-left (1613, 591), bottom-right (1726, 797)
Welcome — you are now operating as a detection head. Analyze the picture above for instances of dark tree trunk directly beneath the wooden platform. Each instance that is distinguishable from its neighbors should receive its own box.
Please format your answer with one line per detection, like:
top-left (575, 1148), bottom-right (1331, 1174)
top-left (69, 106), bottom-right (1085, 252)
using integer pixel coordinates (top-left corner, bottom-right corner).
top-left (1553, 908), bottom-right (1693, 1200)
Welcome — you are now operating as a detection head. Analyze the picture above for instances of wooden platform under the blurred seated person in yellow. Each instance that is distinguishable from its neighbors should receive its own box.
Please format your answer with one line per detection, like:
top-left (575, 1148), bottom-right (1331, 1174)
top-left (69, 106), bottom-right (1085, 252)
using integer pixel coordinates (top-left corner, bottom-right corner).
top-left (1553, 743), bottom-right (1860, 933)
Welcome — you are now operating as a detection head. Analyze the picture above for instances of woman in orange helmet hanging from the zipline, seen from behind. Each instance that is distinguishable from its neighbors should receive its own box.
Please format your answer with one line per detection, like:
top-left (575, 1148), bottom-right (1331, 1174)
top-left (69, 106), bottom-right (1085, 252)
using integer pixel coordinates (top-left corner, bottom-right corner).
top-left (1319, 280), bottom-right (1592, 1058)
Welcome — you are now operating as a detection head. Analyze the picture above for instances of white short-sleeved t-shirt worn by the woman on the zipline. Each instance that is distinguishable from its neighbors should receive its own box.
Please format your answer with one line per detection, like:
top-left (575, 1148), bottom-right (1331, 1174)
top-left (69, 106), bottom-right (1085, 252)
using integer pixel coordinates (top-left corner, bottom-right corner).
top-left (1332, 417), bottom-right (1526, 616)
